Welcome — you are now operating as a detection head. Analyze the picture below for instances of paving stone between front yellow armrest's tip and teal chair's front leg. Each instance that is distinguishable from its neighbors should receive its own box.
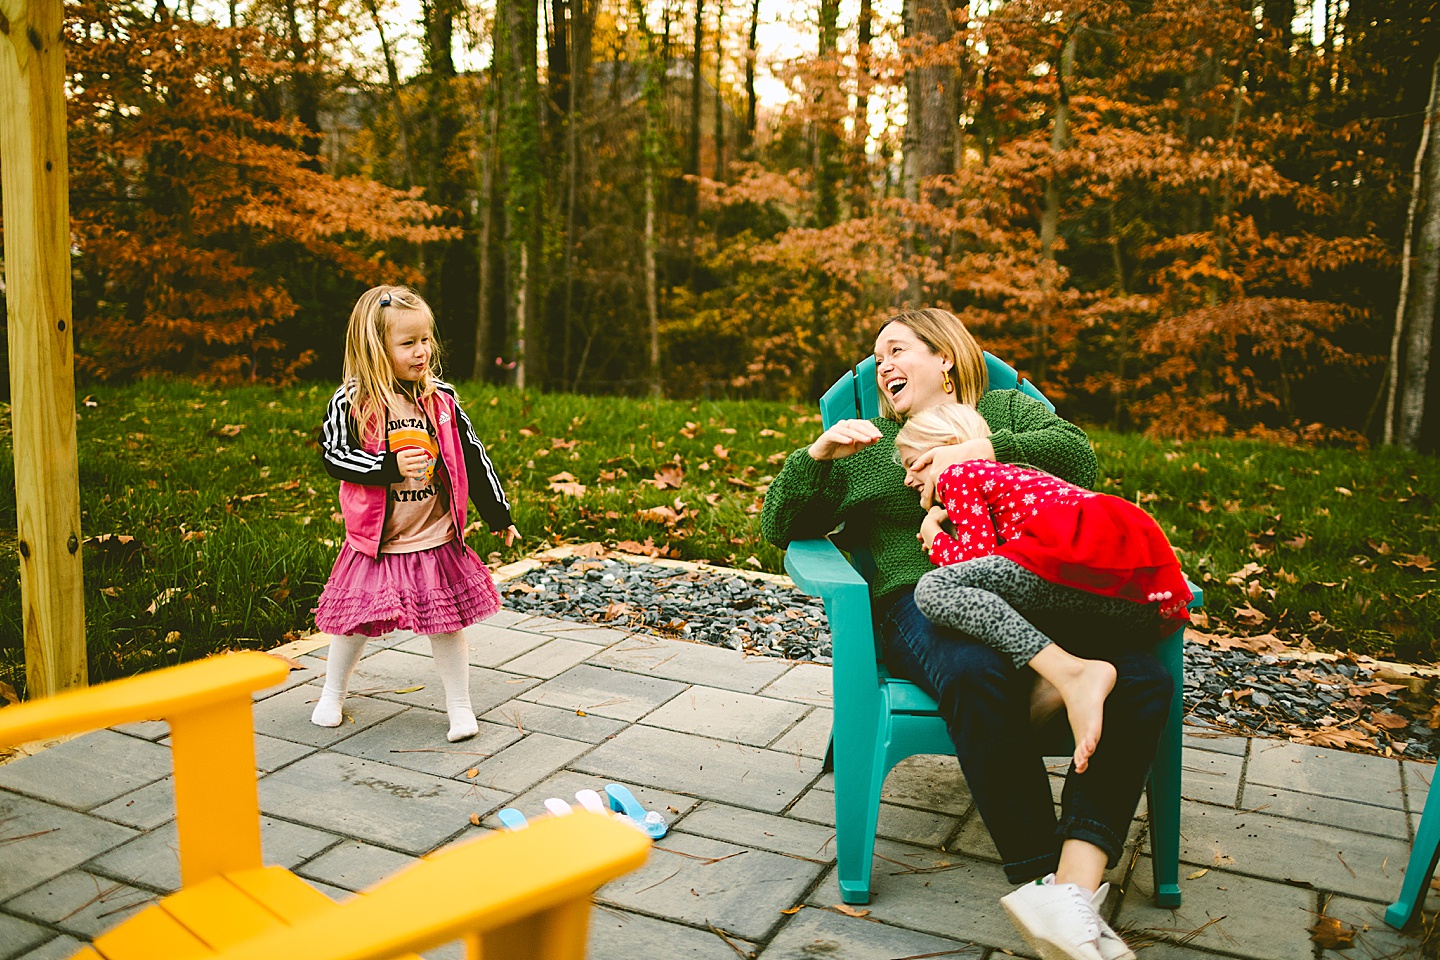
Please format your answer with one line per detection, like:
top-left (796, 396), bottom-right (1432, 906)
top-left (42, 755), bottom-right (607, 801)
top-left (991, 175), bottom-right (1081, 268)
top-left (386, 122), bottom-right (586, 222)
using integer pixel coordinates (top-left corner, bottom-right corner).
top-left (598, 832), bottom-right (824, 940)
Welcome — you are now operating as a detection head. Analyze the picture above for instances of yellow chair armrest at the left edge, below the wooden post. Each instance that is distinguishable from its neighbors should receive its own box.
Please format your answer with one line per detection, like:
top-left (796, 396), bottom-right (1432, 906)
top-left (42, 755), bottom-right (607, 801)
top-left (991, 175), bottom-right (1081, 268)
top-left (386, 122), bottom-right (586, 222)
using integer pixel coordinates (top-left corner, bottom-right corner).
top-left (0, 651), bottom-right (289, 744)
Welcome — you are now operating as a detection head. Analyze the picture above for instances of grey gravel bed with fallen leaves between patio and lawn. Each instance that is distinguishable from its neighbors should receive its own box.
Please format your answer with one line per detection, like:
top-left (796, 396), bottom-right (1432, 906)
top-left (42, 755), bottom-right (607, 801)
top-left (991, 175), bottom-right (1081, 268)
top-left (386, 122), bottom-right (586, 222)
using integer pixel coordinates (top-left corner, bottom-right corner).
top-left (501, 557), bottom-right (1440, 760)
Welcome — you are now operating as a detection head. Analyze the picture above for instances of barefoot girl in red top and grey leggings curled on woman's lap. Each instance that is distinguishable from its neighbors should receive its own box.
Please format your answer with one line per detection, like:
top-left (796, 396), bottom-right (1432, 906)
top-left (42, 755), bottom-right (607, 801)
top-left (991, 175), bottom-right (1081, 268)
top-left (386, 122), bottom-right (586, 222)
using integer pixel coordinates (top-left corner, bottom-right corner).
top-left (896, 403), bottom-right (1191, 773)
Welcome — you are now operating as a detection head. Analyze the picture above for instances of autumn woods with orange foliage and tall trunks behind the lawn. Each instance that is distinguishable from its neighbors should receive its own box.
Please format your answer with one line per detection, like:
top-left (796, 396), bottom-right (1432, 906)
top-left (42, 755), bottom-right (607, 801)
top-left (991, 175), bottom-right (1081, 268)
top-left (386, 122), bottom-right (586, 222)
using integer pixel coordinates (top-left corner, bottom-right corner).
top-left (0, 0), bottom-right (1440, 449)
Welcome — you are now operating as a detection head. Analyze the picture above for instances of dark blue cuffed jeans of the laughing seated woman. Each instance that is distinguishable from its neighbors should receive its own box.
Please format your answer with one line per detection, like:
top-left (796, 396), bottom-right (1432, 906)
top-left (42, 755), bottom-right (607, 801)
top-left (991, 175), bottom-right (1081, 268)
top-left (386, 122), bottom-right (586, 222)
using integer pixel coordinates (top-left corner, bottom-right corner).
top-left (878, 590), bottom-right (1175, 884)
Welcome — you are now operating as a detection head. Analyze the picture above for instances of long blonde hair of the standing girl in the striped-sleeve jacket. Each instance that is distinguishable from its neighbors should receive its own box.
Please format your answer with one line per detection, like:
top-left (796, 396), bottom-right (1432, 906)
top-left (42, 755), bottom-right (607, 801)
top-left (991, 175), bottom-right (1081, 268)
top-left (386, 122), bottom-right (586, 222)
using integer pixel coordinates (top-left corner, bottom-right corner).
top-left (341, 285), bottom-right (441, 439)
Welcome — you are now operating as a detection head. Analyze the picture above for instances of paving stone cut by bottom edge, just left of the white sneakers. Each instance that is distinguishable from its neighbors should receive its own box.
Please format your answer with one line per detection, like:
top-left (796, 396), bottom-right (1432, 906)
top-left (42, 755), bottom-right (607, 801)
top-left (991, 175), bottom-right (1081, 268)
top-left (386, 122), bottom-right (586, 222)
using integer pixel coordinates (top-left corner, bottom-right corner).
top-left (760, 910), bottom-right (985, 960)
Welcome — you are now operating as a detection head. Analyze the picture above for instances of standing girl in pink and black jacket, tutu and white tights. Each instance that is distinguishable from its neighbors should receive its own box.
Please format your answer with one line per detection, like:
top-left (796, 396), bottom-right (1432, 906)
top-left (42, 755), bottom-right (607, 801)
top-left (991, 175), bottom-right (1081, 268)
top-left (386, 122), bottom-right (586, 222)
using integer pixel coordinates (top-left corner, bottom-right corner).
top-left (310, 286), bottom-right (520, 741)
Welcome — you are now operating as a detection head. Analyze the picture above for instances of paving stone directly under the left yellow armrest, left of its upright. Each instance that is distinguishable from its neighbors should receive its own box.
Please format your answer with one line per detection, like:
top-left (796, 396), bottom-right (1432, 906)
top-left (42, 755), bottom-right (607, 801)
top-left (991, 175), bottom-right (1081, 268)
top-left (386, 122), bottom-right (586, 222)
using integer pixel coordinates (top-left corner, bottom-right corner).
top-left (0, 730), bottom-right (170, 810)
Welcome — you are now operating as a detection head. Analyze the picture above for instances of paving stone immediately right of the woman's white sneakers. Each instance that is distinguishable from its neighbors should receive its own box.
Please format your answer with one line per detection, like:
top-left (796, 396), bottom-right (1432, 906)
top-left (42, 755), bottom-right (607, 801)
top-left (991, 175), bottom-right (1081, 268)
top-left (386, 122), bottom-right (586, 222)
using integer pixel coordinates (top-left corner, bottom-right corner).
top-left (1112, 858), bottom-right (1316, 960)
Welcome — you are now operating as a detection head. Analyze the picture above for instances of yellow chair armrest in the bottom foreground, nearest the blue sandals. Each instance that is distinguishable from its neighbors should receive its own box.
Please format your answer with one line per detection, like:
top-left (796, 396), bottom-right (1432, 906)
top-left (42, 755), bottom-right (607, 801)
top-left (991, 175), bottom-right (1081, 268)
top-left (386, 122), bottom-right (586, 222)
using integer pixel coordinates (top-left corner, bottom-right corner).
top-left (216, 812), bottom-right (649, 960)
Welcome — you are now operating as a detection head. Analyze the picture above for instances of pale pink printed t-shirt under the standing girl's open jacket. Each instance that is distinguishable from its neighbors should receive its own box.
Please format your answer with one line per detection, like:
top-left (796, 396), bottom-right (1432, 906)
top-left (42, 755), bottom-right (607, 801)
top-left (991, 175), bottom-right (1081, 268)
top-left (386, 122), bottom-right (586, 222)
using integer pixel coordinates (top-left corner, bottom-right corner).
top-left (380, 396), bottom-right (455, 553)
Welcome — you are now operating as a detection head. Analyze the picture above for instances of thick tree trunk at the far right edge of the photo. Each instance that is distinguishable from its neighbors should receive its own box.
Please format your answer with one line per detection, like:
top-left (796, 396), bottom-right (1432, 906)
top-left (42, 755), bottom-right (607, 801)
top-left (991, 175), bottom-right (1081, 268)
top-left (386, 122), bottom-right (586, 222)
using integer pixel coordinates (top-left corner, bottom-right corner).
top-left (1385, 58), bottom-right (1440, 450)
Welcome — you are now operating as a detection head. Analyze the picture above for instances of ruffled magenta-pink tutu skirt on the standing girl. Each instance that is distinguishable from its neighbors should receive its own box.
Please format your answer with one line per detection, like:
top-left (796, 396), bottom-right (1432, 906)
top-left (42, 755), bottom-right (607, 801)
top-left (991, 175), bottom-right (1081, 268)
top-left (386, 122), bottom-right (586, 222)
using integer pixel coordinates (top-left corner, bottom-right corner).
top-left (315, 538), bottom-right (500, 636)
